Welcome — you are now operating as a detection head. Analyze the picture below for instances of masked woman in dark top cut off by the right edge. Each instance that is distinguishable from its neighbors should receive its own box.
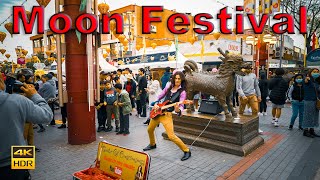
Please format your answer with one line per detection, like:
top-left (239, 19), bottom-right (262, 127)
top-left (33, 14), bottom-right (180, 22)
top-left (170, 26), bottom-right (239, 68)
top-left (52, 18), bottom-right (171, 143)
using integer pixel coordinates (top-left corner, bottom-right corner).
top-left (302, 68), bottom-right (320, 138)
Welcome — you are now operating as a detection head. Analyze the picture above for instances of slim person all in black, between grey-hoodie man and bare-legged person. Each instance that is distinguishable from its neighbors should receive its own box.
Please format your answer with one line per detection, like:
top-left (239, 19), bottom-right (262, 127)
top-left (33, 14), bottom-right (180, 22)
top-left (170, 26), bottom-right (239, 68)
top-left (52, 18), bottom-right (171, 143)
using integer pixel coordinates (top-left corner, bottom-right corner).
top-left (259, 73), bottom-right (269, 116)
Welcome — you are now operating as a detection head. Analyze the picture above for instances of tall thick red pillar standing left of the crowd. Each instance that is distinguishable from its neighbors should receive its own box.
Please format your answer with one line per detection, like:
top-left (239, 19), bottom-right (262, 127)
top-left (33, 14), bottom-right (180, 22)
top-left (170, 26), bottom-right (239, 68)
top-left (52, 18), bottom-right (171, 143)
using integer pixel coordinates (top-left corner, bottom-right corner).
top-left (64, 0), bottom-right (96, 145)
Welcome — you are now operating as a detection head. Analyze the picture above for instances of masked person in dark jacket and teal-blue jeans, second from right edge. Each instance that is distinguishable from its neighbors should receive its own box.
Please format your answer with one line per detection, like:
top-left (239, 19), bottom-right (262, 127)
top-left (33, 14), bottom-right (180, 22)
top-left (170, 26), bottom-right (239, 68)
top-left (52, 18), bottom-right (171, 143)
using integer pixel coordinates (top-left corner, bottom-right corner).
top-left (288, 74), bottom-right (304, 130)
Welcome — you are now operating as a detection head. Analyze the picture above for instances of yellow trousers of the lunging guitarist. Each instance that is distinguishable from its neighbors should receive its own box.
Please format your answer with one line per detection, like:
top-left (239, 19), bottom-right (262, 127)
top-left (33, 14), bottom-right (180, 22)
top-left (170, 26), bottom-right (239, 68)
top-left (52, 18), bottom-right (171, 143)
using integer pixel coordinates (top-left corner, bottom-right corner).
top-left (148, 112), bottom-right (189, 152)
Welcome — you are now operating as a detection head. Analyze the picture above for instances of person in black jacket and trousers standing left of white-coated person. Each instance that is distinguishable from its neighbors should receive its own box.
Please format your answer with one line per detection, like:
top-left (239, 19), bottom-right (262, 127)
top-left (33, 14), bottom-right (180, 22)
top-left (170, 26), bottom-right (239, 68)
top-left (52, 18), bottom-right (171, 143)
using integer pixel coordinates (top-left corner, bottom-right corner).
top-left (138, 68), bottom-right (148, 117)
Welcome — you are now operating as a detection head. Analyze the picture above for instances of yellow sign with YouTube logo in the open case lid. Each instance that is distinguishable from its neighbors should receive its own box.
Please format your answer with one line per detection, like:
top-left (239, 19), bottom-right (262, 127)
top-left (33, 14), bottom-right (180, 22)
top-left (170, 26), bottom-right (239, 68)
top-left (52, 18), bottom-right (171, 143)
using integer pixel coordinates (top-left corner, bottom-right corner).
top-left (96, 142), bottom-right (150, 180)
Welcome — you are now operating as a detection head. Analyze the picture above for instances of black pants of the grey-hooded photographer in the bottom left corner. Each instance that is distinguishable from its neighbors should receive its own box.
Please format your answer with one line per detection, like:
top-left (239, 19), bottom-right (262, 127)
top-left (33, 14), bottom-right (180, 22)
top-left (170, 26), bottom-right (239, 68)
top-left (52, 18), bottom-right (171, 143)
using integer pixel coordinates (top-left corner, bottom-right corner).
top-left (0, 166), bottom-right (30, 180)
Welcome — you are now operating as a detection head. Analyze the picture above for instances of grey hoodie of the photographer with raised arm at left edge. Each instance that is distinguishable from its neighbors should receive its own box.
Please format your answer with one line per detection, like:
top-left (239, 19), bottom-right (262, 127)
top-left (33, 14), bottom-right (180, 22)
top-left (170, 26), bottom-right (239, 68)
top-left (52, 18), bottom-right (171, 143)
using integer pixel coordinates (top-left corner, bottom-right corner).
top-left (0, 90), bottom-right (53, 167)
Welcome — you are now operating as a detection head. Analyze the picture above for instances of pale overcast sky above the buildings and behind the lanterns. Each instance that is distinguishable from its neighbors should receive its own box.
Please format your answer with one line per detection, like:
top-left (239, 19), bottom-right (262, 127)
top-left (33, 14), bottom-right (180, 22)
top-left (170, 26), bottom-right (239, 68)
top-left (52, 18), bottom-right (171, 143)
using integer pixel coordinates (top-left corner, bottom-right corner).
top-left (0, 0), bottom-right (304, 62)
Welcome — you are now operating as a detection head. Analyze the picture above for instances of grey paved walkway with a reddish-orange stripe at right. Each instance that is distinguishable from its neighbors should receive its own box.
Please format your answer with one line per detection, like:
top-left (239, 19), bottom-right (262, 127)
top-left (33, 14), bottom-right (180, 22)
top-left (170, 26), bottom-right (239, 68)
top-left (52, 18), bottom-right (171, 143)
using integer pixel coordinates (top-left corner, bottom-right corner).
top-left (32, 103), bottom-right (320, 180)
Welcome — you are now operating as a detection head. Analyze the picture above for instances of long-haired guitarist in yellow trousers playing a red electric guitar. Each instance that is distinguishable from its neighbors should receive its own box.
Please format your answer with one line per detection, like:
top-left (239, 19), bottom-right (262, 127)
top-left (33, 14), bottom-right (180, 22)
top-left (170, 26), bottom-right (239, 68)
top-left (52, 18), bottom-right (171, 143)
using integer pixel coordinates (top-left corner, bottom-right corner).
top-left (143, 71), bottom-right (191, 161)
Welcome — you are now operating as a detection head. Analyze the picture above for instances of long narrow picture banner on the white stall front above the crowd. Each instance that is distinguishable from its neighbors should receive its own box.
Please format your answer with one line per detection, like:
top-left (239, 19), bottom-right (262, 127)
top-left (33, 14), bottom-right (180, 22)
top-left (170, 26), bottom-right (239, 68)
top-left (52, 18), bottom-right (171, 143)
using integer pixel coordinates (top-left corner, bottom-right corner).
top-left (118, 51), bottom-right (176, 65)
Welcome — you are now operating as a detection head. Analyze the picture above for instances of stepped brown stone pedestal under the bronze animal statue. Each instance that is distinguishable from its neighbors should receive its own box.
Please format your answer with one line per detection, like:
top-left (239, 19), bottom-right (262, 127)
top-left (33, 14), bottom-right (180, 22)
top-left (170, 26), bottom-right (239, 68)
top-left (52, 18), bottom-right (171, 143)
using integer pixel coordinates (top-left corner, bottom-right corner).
top-left (162, 112), bottom-right (264, 156)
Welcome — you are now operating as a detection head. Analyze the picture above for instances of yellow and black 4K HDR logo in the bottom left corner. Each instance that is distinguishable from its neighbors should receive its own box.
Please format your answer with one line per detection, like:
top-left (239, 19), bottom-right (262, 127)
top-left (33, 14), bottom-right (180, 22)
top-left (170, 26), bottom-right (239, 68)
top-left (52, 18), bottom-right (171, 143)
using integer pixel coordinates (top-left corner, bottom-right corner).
top-left (11, 146), bottom-right (36, 169)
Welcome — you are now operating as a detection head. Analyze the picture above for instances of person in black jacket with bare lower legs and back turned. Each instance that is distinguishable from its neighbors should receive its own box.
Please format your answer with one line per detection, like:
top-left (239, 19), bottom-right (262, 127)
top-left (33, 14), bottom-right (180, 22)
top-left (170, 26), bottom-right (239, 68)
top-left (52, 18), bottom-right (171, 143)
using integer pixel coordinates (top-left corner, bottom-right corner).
top-left (269, 68), bottom-right (289, 127)
